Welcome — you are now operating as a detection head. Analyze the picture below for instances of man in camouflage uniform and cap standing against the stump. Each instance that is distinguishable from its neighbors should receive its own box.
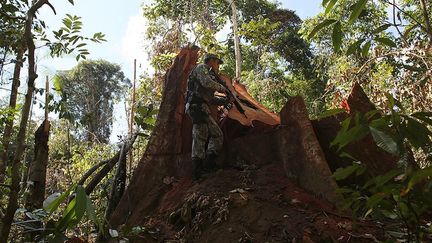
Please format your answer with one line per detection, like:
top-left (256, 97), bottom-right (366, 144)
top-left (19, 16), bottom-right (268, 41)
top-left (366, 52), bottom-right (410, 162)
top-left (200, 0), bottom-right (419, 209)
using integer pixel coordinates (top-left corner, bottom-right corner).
top-left (186, 54), bottom-right (228, 180)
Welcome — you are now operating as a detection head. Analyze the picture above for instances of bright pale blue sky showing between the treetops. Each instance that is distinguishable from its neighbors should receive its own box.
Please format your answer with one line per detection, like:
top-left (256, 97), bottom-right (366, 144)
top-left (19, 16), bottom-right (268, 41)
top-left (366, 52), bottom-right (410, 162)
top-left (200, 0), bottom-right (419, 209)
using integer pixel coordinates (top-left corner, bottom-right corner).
top-left (36, 0), bottom-right (322, 141)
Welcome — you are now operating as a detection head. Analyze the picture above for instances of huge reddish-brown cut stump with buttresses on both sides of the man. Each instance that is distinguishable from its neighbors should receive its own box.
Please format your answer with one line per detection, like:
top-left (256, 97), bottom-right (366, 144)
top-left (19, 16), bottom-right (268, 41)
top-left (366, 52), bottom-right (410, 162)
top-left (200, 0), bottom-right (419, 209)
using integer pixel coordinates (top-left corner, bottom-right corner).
top-left (110, 48), bottom-right (398, 231)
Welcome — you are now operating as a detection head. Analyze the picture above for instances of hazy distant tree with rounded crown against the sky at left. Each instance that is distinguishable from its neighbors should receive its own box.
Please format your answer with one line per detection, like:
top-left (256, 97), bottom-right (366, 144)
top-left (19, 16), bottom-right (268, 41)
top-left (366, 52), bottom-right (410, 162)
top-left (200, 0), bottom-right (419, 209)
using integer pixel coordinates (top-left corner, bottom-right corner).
top-left (56, 60), bottom-right (125, 143)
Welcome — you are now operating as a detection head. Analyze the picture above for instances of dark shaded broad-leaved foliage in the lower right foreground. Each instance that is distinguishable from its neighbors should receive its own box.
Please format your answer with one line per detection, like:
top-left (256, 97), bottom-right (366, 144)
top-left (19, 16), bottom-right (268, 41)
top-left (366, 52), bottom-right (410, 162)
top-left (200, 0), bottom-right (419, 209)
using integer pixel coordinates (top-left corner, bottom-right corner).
top-left (332, 94), bottom-right (432, 241)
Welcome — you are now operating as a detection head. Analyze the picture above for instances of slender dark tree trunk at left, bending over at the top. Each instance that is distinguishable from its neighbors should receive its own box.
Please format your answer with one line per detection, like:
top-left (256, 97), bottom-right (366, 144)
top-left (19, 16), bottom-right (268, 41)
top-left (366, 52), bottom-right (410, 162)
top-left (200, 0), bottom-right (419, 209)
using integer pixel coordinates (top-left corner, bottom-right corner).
top-left (0, 0), bottom-right (49, 243)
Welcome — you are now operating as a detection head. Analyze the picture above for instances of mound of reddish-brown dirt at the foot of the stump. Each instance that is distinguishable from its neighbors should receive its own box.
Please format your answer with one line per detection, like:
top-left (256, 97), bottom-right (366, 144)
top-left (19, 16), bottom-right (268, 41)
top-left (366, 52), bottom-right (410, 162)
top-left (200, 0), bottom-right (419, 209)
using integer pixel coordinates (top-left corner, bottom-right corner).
top-left (122, 164), bottom-right (384, 242)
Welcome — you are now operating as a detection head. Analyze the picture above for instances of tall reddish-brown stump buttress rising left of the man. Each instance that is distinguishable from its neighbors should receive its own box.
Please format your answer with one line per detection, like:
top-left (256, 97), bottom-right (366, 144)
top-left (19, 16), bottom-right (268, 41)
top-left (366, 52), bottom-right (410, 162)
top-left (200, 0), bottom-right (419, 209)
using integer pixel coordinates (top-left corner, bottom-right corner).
top-left (110, 48), bottom-right (199, 226)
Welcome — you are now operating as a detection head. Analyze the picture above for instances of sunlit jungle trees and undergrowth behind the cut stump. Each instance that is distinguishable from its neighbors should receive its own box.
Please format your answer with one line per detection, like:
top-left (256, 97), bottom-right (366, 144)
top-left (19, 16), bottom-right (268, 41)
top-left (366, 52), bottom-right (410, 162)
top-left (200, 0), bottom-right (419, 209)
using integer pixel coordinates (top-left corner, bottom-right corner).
top-left (0, 0), bottom-right (432, 242)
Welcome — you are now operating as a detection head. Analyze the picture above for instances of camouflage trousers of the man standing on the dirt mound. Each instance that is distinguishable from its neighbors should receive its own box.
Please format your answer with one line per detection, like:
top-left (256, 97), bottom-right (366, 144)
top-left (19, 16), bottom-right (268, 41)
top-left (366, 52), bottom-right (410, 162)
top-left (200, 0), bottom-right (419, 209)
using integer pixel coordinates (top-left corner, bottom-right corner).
top-left (186, 104), bottom-right (223, 159)
